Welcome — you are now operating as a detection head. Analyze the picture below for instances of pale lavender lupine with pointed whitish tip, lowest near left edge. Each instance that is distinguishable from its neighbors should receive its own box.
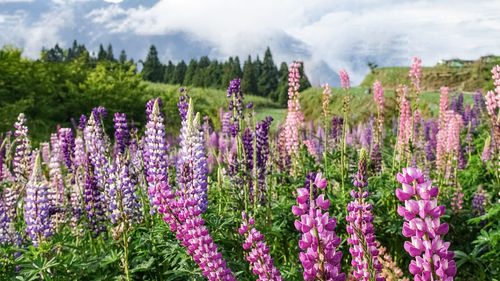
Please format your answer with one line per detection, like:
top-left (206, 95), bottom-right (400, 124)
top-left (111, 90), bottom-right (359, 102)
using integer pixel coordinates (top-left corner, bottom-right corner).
top-left (24, 155), bottom-right (52, 247)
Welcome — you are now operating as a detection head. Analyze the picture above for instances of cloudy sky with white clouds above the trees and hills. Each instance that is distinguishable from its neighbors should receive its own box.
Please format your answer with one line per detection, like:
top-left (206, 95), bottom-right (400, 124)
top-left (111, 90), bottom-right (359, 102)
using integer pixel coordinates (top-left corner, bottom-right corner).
top-left (0, 0), bottom-right (500, 85)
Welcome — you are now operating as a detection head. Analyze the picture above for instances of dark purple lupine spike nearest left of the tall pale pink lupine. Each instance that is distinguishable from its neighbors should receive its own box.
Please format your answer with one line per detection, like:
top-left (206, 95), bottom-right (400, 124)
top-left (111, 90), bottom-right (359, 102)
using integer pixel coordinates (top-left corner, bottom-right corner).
top-left (255, 116), bottom-right (273, 200)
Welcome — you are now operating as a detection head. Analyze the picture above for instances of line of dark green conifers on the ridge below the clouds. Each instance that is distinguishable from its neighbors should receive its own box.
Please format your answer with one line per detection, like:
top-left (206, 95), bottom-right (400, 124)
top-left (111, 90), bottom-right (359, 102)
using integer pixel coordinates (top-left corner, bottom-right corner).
top-left (41, 40), bottom-right (311, 105)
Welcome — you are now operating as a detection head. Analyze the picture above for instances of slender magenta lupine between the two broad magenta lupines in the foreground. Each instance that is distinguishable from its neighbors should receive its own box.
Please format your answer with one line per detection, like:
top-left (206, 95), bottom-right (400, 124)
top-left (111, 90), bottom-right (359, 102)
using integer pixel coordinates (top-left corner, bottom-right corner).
top-left (346, 149), bottom-right (385, 281)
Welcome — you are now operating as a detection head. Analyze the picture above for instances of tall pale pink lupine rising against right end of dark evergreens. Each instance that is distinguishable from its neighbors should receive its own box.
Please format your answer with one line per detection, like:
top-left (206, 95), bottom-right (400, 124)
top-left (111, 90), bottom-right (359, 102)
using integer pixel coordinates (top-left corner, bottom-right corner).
top-left (285, 62), bottom-right (303, 155)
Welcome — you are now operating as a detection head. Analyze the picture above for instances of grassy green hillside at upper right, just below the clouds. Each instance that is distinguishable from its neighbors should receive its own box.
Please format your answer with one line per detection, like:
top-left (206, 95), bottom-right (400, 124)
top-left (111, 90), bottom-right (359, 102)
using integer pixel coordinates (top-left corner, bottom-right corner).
top-left (361, 56), bottom-right (500, 92)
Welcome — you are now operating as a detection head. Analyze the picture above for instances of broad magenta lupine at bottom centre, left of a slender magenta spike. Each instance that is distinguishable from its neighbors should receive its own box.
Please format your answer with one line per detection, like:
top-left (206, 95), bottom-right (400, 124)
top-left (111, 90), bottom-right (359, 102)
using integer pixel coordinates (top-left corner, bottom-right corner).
top-left (292, 173), bottom-right (346, 281)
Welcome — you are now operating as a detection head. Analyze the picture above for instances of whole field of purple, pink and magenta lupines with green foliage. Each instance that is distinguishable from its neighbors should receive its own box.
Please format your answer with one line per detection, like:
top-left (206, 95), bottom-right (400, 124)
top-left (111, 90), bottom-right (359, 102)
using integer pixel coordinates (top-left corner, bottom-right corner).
top-left (0, 58), bottom-right (500, 281)
